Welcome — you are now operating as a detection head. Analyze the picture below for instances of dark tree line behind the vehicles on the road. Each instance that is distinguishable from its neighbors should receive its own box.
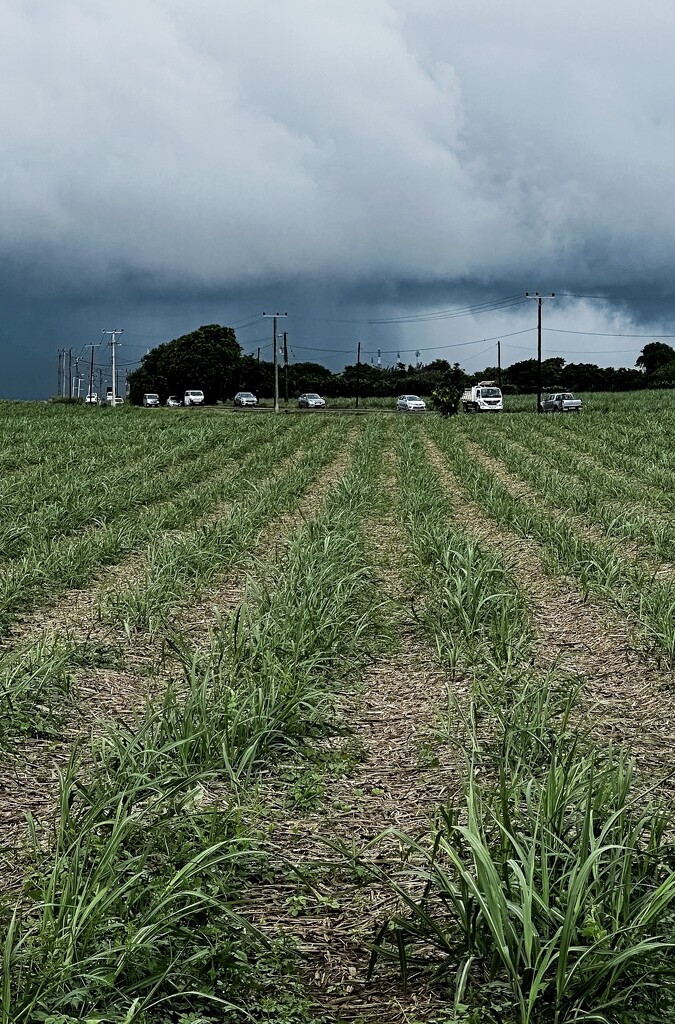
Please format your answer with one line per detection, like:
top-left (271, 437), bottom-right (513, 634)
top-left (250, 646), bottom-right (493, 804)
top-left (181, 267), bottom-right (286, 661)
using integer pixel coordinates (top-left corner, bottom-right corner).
top-left (129, 324), bottom-right (675, 404)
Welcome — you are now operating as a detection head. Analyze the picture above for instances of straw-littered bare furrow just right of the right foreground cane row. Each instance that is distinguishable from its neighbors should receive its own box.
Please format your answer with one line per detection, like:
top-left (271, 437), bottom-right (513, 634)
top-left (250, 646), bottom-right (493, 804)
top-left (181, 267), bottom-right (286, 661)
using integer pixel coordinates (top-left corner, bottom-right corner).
top-left (426, 439), bottom-right (675, 788)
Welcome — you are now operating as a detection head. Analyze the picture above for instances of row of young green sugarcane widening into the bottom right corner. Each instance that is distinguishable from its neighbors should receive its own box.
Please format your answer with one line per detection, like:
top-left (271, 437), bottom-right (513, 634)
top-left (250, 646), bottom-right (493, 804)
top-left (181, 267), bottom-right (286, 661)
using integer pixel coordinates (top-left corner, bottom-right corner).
top-left (360, 423), bottom-right (675, 1024)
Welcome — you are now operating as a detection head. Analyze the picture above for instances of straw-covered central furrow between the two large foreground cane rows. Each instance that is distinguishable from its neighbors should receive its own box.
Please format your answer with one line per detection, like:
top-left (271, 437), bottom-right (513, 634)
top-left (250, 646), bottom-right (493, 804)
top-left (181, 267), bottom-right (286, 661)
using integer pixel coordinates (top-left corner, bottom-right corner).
top-left (242, 466), bottom-right (468, 1024)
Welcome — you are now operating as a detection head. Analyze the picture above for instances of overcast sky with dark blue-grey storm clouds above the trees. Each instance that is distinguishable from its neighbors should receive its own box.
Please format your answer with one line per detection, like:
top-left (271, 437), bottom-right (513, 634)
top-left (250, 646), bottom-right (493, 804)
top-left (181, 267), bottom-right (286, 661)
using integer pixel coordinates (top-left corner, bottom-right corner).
top-left (0, 0), bottom-right (675, 397)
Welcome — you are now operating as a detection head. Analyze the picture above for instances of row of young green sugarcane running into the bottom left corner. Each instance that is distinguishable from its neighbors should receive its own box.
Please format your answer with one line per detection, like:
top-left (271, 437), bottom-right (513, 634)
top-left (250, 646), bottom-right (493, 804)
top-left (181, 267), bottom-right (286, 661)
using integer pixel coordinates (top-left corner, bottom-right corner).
top-left (0, 423), bottom-right (391, 1024)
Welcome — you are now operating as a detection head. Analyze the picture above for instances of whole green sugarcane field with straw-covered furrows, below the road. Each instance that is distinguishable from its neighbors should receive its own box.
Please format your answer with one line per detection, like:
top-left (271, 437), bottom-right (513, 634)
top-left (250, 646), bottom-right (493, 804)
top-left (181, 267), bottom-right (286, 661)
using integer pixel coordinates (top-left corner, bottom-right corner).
top-left (0, 393), bottom-right (675, 1024)
